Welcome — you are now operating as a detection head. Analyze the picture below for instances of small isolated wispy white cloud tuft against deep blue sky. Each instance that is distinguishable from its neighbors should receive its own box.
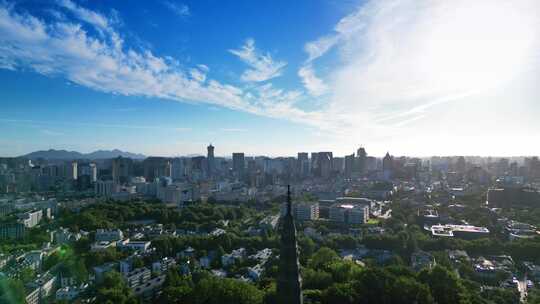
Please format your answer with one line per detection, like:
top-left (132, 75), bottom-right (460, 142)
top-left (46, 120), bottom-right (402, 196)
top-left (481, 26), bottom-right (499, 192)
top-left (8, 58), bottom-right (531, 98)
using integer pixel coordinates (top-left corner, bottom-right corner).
top-left (229, 39), bottom-right (287, 82)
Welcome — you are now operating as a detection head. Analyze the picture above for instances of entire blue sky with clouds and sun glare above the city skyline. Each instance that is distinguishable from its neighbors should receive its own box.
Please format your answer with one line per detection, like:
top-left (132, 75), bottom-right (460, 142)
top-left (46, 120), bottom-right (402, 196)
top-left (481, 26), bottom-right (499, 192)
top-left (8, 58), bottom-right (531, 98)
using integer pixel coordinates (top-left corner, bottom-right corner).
top-left (0, 0), bottom-right (540, 156)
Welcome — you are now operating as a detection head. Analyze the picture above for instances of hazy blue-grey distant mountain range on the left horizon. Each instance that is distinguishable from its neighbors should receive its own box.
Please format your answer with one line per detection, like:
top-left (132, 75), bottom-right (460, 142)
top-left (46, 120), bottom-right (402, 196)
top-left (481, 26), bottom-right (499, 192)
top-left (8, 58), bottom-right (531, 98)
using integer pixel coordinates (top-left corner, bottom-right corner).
top-left (21, 149), bottom-right (146, 160)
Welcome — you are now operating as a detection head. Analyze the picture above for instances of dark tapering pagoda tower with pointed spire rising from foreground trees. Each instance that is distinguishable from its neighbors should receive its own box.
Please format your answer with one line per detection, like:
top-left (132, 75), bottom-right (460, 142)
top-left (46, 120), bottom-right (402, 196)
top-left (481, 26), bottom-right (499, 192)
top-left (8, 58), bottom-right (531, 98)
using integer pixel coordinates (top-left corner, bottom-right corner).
top-left (277, 186), bottom-right (303, 304)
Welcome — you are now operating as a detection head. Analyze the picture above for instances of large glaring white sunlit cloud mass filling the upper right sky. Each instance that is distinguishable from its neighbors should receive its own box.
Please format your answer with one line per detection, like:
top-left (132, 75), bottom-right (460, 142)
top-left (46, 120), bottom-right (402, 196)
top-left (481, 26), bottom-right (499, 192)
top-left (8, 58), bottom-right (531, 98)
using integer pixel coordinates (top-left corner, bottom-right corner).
top-left (299, 0), bottom-right (540, 145)
